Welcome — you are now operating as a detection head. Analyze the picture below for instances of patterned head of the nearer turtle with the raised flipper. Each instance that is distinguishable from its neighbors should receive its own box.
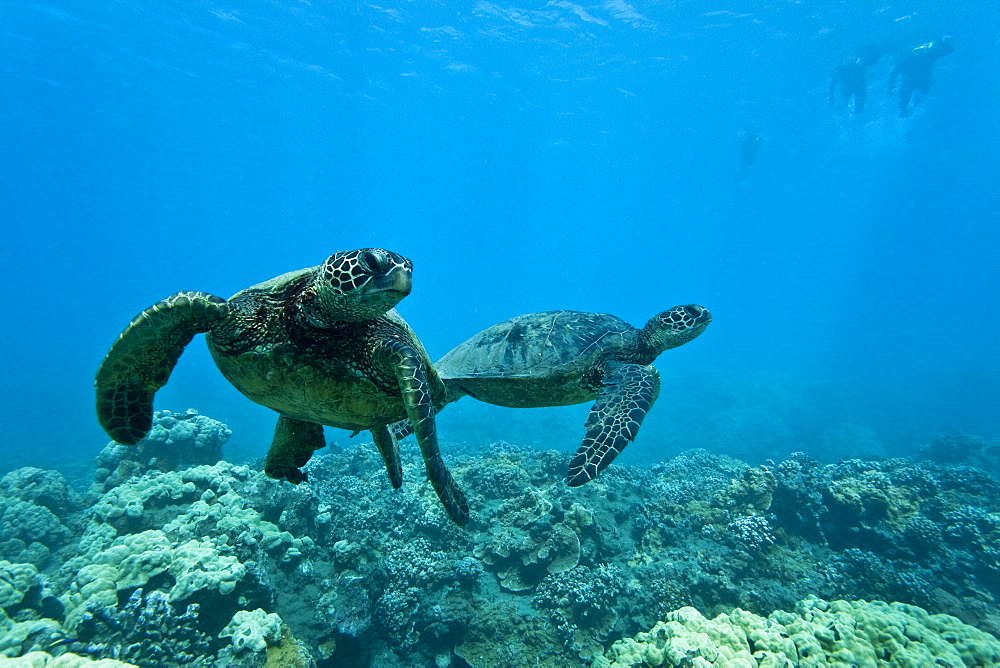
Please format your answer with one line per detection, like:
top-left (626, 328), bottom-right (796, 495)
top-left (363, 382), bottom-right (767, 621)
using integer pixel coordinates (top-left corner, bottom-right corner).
top-left (302, 248), bottom-right (413, 327)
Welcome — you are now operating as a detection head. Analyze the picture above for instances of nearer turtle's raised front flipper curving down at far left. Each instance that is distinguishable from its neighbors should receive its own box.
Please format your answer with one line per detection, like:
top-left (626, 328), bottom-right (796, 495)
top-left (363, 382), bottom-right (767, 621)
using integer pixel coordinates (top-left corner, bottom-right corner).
top-left (95, 292), bottom-right (229, 445)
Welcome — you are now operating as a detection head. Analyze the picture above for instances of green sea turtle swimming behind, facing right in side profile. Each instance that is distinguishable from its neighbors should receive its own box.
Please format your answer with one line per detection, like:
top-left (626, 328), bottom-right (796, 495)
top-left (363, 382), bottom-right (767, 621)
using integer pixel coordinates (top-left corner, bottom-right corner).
top-left (393, 304), bottom-right (712, 487)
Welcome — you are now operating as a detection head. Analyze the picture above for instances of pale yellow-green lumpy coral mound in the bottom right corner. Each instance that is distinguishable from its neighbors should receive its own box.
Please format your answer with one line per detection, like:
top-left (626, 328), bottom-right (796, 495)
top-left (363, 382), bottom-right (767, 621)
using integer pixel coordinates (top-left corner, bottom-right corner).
top-left (594, 597), bottom-right (1000, 668)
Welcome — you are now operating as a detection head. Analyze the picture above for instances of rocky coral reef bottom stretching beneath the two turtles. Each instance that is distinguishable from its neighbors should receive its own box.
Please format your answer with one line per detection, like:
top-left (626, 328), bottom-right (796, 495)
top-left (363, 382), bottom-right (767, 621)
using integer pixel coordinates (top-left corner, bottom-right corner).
top-left (0, 411), bottom-right (1000, 668)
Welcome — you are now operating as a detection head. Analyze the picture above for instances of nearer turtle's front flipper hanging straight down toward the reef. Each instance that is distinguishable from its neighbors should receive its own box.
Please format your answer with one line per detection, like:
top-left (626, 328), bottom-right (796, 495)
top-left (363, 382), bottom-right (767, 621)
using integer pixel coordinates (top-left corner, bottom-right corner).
top-left (380, 341), bottom-right (469, 526)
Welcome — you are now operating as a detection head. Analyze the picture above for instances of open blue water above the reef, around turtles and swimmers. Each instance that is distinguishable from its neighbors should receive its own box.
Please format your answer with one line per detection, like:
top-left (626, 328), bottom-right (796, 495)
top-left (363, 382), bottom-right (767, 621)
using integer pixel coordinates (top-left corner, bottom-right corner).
top-left (0, 0), bottom-right (1000, 478)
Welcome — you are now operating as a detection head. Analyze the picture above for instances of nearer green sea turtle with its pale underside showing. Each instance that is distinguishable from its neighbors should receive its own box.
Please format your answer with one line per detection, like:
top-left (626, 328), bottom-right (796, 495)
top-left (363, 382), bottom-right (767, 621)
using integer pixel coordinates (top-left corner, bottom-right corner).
top-left (96, 248), bottom-right (469, 524)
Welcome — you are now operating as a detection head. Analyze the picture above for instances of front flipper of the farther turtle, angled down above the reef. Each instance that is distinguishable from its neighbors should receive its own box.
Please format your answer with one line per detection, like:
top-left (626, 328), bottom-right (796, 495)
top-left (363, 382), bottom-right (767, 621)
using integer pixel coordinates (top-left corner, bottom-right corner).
top-left (567, 362), bottom-right (660, 487)
